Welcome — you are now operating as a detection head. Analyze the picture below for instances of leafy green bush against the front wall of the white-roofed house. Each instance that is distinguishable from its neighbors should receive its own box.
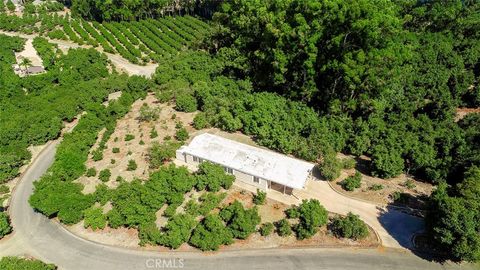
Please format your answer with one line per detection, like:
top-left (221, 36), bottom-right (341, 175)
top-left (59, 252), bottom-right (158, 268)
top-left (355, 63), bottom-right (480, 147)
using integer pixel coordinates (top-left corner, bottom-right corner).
top-left (195, 162), bottom-right (235, 192)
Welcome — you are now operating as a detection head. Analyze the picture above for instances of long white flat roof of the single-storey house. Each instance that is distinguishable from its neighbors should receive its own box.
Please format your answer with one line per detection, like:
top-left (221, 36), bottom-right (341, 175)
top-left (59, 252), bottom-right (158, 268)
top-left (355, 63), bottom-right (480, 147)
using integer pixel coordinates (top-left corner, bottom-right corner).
top-left (178, 133), bottom-right (315, 189)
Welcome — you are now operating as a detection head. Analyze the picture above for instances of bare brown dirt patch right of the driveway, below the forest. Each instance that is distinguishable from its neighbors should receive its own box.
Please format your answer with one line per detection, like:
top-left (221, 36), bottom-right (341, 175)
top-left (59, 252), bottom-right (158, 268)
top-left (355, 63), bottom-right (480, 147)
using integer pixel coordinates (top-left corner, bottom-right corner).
top-left (330, 155), bottom-right (433, 209)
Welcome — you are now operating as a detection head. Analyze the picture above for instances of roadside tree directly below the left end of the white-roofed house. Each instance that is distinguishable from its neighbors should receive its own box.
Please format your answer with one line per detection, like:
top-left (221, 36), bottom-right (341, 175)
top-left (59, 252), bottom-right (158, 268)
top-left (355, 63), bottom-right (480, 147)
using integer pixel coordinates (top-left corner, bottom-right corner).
top-left (160, 214), bottom-right (197, 249)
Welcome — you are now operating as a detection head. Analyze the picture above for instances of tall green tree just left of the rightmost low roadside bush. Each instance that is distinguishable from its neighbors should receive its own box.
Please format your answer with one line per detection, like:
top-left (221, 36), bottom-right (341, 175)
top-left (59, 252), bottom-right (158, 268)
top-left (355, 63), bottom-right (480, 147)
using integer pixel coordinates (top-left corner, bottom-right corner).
top-left (294, 199), bottom-right (328, 240)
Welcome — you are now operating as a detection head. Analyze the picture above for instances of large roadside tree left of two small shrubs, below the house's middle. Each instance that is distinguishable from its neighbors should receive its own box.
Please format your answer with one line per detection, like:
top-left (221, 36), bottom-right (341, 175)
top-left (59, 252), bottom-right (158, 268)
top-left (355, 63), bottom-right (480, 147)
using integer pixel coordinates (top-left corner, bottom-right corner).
top-left (220, 201), bottom-right (260, 239)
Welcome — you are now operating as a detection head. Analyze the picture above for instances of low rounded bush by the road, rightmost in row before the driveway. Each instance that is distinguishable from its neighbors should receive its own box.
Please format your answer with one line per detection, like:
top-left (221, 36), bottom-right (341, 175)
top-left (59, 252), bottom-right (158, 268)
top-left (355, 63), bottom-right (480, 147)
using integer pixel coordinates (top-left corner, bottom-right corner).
top-left (330, 212), bottom-right (369, 240)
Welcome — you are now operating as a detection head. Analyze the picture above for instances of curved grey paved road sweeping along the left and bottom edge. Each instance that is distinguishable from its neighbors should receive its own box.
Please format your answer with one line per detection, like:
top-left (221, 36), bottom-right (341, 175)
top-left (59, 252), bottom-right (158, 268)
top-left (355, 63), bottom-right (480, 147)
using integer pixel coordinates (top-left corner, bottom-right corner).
top-left (0, 142), bottom-right (474, 270)
